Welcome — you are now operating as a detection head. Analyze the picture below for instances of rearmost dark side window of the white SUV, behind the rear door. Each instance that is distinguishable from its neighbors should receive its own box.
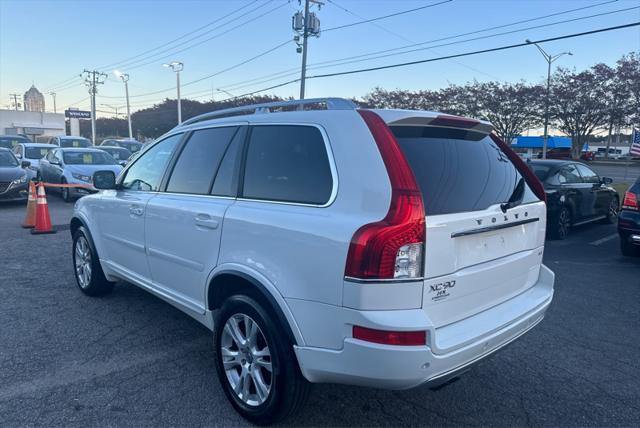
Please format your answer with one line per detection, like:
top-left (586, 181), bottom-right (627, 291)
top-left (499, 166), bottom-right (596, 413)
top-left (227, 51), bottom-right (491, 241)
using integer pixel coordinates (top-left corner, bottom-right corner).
top-left (243, 125), bottom-right (333, 205)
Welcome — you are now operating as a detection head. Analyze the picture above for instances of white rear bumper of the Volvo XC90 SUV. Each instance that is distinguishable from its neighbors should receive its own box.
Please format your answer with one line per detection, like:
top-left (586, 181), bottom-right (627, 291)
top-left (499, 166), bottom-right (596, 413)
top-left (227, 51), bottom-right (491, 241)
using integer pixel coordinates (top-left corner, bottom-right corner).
top-left (295, 265), bottom-right (554, 389)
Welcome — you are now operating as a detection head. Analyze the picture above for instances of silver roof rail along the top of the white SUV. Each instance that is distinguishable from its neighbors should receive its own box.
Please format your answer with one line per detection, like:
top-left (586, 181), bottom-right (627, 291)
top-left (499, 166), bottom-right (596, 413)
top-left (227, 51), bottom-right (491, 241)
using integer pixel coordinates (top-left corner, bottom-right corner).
top-left (180, 98), bottom-right (358, 126)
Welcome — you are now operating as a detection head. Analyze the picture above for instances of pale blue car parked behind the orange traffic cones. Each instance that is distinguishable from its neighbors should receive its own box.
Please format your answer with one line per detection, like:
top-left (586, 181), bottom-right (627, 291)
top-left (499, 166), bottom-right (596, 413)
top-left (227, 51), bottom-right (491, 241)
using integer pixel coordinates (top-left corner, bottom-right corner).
top-left (38, 147), bottom-right (122, 202)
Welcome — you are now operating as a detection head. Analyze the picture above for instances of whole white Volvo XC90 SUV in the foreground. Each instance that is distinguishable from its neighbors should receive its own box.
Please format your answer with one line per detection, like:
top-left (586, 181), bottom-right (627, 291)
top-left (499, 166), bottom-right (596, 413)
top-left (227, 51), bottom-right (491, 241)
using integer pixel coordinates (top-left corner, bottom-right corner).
top-left (71, 98), bottom-right (554, 424)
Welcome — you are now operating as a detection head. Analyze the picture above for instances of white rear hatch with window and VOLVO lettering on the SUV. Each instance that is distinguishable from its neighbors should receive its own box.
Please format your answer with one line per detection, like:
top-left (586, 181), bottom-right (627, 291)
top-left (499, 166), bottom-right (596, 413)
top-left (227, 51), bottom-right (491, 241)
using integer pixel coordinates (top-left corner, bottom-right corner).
top-left (380, 112), bottom-right (546, 328)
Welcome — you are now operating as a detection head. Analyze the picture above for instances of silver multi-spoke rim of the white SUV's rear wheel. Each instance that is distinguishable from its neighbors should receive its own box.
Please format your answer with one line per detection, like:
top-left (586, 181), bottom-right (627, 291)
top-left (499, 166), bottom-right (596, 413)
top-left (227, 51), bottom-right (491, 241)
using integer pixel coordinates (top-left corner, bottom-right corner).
top-left (220, 314), bottom-right (273, 406)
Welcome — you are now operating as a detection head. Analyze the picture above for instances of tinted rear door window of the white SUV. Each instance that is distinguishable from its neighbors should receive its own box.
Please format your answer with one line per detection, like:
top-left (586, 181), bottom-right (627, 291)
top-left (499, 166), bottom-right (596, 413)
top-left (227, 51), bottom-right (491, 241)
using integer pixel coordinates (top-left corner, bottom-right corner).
top-left (167, 126), bottom-right (238, 195)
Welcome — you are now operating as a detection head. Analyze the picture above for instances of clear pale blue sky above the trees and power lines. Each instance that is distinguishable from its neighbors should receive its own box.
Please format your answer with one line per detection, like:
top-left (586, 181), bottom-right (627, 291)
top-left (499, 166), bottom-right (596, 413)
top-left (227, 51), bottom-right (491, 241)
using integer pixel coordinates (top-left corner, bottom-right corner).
top-left (0, 0), bottom-right (640, 117)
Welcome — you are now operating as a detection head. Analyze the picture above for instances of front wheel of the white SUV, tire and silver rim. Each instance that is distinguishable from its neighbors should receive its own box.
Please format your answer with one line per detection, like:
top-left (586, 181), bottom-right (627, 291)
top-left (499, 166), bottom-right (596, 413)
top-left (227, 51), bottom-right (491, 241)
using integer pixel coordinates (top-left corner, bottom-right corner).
top-left (71, 226), bottom-right (114, 296)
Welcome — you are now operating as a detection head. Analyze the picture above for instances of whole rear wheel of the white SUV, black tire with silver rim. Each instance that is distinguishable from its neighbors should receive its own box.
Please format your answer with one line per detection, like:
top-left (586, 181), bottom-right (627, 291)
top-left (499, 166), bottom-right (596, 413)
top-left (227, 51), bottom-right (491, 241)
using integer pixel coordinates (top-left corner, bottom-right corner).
top-left (214, 295), bottom-right (309, 425)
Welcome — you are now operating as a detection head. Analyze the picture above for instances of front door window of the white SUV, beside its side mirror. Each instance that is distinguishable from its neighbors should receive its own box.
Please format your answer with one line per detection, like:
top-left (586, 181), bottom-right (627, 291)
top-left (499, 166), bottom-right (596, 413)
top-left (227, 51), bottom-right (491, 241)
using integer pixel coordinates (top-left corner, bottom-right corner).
top-left (122, 134), bottom-right (182, 192)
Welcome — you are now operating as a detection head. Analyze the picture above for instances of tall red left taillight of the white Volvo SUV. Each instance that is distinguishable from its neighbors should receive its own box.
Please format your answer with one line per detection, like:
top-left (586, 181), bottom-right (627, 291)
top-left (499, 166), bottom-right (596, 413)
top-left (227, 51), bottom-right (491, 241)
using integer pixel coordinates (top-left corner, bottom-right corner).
top-left (345, 110), bottom-right (425, 279)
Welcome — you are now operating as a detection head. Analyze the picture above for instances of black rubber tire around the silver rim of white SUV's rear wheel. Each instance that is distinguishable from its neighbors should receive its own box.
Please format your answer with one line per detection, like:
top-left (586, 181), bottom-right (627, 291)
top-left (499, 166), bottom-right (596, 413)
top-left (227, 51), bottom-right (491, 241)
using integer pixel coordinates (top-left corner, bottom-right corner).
top-left (214, 294), bottom-right (310, 425)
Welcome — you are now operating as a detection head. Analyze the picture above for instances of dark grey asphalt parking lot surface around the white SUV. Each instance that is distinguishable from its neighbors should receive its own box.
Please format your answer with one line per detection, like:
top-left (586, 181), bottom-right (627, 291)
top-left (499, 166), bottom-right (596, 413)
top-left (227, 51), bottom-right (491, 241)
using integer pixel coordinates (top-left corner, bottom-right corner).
top-left (0, 195), bottom-right (640, 427)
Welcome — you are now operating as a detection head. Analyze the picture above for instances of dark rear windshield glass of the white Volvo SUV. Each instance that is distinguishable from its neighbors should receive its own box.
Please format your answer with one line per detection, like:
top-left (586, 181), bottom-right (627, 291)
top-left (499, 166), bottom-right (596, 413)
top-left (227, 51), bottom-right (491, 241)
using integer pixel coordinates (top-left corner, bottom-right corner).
top-left (391, 126), bottom-right (537, 215)
